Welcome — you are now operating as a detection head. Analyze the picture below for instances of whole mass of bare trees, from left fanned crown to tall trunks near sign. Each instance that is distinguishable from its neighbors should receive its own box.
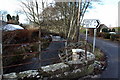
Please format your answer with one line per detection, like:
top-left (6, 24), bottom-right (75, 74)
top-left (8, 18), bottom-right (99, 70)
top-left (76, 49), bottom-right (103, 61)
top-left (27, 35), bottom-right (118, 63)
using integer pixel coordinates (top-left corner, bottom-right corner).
top-left (21, 0), bottom-right (91, 39)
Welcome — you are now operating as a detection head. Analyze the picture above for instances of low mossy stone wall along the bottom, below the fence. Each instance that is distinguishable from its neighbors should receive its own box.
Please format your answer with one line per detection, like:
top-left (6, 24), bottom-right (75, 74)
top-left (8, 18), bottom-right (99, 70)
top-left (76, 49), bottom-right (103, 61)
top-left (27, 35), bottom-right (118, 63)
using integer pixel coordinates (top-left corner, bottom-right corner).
top-left (3, 50), bottom-right (95, 80)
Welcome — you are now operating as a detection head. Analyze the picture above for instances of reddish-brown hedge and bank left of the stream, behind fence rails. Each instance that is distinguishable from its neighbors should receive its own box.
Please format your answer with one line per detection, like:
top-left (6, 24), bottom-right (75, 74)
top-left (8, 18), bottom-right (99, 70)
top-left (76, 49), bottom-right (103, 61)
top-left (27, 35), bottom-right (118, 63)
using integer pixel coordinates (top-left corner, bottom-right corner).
top-left (3, 29), bottom-right (52, 66)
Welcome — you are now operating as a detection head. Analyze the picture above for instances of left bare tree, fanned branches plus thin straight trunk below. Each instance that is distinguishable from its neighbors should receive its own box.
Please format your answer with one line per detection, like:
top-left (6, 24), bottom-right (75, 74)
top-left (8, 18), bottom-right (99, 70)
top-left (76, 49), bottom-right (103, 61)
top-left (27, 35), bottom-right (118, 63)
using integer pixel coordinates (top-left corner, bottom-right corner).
top-left (21, 0), bottom-right (45, 66)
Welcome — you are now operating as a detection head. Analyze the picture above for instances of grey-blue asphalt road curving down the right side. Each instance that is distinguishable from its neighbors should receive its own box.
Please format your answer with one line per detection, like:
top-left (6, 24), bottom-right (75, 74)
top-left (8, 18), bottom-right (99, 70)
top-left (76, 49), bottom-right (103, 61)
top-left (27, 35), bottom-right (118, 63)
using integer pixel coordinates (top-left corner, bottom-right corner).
top-left (81, 35), bottom-right (120, 78)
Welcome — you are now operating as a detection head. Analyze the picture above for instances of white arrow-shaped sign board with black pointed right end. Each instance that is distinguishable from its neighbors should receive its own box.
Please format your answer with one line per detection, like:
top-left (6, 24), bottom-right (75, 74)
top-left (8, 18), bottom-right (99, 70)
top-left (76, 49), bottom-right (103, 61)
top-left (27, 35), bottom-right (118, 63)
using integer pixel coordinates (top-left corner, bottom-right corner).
top-left (83, 19), bottom-right (100, 28)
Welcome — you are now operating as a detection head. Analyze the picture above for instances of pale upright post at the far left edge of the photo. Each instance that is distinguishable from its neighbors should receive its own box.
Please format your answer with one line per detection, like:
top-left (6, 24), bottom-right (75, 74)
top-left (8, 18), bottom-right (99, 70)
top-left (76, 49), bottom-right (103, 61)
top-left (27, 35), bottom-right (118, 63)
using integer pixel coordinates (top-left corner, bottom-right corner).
top-left (0, 14), bottom-right (3, 80)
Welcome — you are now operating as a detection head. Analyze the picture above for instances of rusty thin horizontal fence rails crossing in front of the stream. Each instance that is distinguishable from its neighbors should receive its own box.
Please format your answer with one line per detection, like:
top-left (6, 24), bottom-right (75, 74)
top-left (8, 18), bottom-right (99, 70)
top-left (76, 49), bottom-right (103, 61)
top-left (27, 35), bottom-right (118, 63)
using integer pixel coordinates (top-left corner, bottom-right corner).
top-left (2, 41), bottom-right (79, 72)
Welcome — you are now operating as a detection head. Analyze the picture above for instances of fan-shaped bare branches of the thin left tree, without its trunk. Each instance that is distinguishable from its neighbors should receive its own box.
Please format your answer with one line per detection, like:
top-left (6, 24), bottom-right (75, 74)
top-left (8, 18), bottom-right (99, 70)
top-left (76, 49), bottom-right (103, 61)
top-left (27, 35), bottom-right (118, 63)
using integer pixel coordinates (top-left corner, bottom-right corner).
top-left (21, 0), bottom-right (44, 25)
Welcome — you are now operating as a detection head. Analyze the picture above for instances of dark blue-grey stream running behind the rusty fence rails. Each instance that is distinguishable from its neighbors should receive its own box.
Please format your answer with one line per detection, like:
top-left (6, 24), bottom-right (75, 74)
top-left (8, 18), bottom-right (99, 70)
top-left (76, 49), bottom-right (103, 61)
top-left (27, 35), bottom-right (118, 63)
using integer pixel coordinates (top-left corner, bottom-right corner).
top-left (3, 36), bottom-right (64, 74)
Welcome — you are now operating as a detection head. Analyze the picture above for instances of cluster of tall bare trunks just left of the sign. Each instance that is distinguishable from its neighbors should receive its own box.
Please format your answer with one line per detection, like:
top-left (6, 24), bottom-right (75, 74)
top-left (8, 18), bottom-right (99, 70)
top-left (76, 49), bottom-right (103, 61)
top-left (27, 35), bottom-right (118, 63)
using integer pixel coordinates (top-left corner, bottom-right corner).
top-left (51, 0), bottom-right (90, 41)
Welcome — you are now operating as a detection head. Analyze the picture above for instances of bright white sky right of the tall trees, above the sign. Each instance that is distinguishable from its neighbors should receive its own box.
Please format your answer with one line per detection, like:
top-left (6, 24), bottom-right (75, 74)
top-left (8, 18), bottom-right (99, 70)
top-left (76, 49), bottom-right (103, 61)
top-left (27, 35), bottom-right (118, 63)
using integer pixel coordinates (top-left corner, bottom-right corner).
top-left (84, 0), bottom-right (119, 27)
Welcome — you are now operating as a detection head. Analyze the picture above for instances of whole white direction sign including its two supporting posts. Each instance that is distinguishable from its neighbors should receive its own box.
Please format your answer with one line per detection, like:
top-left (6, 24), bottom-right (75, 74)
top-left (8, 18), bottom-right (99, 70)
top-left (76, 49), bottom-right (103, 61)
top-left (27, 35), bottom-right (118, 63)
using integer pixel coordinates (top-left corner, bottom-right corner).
top-left (83, 19), bottom-right (100, 57)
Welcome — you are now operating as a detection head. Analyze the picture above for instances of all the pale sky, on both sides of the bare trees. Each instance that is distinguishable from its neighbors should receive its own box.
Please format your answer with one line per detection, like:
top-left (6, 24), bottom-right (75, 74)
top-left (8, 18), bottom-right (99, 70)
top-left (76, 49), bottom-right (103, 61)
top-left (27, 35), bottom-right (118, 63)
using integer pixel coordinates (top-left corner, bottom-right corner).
top-left (0, 0), bottom-right (120, 27)
